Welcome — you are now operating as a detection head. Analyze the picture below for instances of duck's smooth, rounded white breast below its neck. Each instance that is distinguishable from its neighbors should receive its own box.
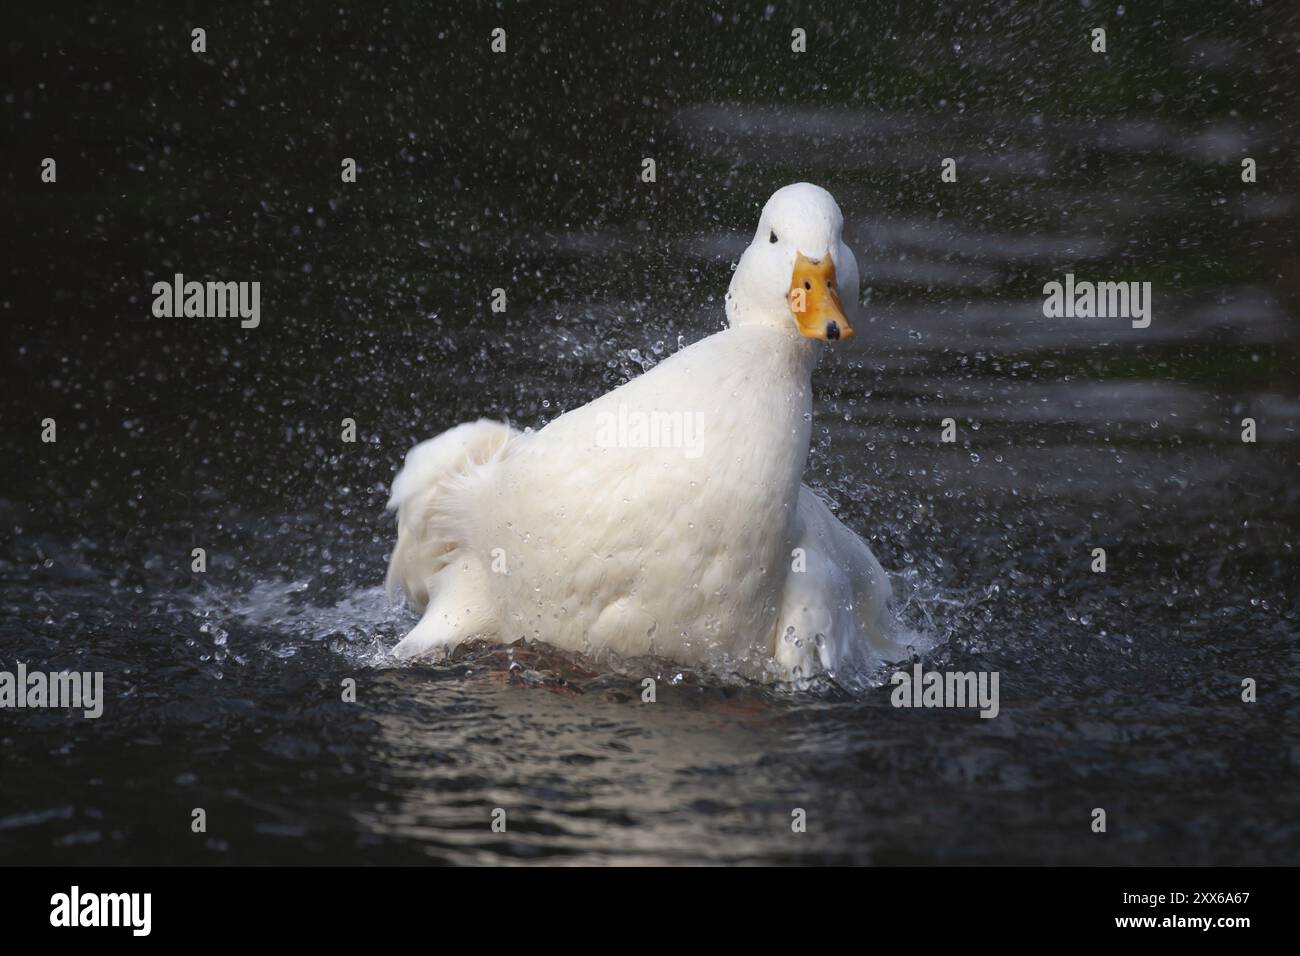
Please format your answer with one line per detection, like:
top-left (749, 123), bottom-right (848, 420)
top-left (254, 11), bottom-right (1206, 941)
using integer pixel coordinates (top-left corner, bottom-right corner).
top-left (478, 325), bottom-right (810, 662)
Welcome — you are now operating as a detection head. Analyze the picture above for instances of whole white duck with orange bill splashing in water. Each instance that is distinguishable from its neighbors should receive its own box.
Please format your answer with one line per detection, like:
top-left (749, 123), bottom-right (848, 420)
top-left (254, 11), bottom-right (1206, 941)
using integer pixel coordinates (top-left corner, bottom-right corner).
top-left (387, 182), bottom-right (905, 683)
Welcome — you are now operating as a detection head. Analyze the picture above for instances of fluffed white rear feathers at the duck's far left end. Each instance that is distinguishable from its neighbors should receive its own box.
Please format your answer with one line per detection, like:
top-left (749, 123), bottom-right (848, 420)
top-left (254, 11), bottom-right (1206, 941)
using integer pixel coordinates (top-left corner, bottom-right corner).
top-left (386, 419), bottom-right (519, 613)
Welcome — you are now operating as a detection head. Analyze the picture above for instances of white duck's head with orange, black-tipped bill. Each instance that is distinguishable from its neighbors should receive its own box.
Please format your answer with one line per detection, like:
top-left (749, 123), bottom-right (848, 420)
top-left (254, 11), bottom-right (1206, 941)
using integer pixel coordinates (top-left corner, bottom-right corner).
top-left (727, 182), bottom-right (858, 341)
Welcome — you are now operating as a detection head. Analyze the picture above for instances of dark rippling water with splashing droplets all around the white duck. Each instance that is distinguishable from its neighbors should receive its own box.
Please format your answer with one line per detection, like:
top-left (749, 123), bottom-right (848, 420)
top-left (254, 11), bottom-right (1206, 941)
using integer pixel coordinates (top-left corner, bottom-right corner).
top-left (0, 3), bottom-right (1300, 864)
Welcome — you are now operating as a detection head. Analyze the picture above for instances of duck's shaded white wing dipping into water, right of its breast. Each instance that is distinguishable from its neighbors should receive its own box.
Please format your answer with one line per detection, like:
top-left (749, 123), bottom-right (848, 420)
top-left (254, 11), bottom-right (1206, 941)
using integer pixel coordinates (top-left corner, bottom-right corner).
top-left (775, 485), bottom-right (907, 683)
